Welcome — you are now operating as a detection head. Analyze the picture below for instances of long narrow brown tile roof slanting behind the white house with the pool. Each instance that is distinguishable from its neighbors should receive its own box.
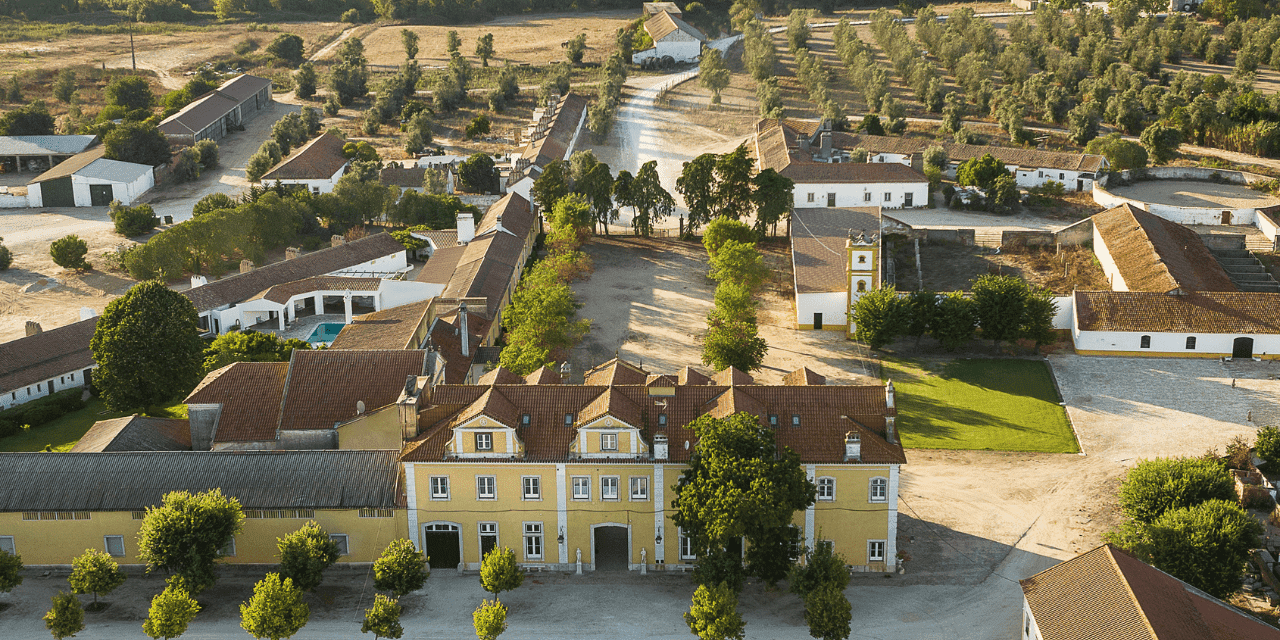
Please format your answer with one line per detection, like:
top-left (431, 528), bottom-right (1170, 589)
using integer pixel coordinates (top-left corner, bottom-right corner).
top-left (182, 233), bottom-right (404, 312)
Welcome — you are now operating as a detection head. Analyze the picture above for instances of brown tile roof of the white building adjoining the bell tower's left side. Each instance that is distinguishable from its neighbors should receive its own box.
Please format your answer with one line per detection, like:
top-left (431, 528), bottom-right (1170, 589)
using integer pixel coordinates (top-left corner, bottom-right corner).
top-left (791, 206), bottom-right (881, 293)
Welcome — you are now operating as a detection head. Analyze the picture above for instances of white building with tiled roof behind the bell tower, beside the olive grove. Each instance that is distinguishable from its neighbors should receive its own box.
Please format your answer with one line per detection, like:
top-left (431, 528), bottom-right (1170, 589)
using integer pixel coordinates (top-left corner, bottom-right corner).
top-left (755, 120), bottom-right (929, 209)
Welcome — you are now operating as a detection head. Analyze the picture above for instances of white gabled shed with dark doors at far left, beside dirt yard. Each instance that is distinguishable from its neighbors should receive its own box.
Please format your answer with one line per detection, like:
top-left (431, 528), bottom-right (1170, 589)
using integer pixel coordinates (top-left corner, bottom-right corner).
top-left (27, 146), bottom-right (156, 207)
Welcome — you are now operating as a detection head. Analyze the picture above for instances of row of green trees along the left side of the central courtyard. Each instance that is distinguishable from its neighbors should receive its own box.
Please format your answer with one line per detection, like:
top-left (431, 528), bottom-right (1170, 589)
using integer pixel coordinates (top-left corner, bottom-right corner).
top-left (502, 193), bottom-right (593, 375)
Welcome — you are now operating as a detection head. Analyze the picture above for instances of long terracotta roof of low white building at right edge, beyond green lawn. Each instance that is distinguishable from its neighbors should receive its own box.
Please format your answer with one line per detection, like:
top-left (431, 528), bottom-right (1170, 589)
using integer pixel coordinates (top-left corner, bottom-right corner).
top-left (1075, 291), bottom-right (1280, 334)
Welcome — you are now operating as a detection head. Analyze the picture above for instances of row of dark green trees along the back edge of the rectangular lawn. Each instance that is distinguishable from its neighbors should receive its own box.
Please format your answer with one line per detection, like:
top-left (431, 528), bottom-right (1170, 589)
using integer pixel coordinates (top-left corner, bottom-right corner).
top-left (852, 275), bottom-right (1057, 351)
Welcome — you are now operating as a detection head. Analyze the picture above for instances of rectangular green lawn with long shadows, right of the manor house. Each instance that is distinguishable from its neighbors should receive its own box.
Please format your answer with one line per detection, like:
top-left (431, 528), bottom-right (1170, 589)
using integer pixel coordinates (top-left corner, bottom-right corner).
top-left (882, 358), bottom-right (1080, 453)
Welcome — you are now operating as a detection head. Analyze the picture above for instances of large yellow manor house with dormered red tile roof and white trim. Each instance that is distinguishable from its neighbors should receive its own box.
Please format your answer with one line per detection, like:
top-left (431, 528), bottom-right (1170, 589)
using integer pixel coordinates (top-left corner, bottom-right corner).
top-left (394, 360), bottom-right (906, 571)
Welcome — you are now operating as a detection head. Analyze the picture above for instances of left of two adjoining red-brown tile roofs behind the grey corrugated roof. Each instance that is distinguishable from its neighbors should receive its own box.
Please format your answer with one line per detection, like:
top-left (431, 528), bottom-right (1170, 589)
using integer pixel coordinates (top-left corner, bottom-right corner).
top-left (186, 362), bottom-right (289, 443)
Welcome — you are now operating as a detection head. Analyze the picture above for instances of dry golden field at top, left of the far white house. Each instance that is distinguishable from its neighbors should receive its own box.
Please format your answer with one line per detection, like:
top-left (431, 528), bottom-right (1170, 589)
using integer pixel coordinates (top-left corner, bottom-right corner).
top-left (365, 10), bottom-right (640, 67)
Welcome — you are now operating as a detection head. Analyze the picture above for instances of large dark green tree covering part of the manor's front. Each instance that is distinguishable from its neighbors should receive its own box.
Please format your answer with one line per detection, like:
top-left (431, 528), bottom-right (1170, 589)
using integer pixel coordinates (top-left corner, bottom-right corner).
top-left (672, 412), bottom-right (818, 585)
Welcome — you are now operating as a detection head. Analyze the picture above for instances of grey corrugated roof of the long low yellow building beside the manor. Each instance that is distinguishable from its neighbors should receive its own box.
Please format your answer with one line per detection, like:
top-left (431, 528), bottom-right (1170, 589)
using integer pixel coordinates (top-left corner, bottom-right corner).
top-left (0, 451), bottom-right (399, 512)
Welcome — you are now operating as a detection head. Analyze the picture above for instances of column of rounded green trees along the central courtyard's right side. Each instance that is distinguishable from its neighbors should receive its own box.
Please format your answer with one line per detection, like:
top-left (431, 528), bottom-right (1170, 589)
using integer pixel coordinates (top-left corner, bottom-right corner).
top-left (703, 218), bottom-right (769, 371)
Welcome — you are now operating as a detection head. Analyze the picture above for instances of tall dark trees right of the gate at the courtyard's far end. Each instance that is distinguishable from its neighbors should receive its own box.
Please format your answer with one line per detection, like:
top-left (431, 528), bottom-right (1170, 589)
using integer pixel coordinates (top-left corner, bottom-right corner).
top-left (676, 145), bottom-right (795, 236)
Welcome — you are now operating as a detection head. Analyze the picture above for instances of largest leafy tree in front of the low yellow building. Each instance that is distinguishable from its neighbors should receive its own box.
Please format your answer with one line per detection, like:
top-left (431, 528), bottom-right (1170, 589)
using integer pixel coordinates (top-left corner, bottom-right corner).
top-left (138, 489), bottom-right (244, 594)
